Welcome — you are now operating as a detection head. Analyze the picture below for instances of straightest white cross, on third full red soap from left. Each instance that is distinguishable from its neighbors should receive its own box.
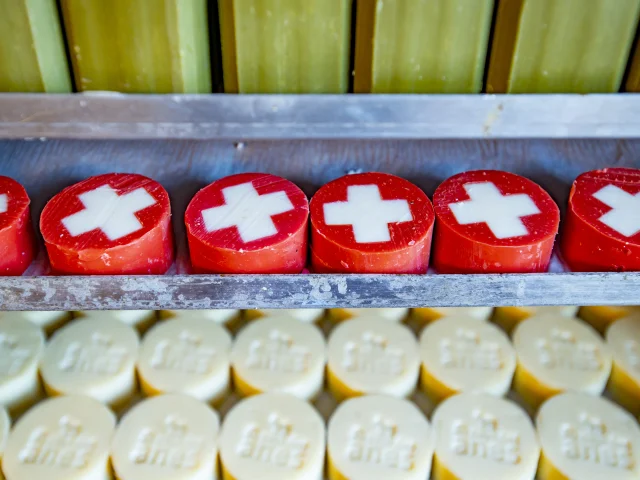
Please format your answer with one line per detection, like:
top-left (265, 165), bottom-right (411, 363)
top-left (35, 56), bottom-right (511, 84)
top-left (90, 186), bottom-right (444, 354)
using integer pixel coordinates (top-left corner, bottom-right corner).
top-left (323, 185), bottom-right (413, 243)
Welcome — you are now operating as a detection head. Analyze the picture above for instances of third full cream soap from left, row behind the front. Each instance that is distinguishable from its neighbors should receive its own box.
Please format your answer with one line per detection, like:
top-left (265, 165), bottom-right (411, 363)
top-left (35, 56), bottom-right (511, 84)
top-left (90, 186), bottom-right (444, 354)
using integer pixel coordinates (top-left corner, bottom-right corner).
top-left (231, 316), bottom-right (327, 400)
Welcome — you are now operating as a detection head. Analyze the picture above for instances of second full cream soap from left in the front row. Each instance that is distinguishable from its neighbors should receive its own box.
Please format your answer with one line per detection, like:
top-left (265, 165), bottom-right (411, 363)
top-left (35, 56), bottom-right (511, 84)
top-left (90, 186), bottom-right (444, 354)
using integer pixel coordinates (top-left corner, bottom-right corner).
top-left (111, 394), bottom-right (220, 480)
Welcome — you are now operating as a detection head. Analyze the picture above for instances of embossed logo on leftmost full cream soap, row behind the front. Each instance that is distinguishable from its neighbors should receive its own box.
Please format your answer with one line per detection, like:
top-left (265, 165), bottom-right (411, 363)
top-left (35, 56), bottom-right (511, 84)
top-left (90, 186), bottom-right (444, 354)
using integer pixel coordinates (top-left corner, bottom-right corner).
top-left (58, 332), bottom-right (127, 375)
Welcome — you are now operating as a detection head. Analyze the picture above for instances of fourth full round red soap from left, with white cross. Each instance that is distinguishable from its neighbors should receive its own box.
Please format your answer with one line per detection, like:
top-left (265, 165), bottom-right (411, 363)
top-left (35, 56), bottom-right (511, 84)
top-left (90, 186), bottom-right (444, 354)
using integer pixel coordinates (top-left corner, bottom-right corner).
top-left (433, 170), bottom-right (560, 273)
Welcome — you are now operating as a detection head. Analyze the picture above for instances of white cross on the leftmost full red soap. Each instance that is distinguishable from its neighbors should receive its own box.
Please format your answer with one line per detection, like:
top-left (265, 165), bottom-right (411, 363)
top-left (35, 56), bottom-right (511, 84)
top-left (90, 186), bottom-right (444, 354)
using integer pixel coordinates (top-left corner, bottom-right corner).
top-left (62, 185), bottom-right (156, 241)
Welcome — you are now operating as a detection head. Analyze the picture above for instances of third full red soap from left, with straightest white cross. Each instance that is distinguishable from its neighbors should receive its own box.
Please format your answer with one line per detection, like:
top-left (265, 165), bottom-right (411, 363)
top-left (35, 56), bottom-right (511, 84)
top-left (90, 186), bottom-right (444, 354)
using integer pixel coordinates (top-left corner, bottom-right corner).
top-left (310, 172), bottom-right (434, 273)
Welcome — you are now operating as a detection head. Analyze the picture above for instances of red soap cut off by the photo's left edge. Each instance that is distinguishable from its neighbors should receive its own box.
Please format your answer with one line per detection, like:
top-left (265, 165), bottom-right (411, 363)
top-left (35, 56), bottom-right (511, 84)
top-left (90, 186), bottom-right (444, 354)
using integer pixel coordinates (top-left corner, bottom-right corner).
top-left (0, 176), bottom-right (35, 276)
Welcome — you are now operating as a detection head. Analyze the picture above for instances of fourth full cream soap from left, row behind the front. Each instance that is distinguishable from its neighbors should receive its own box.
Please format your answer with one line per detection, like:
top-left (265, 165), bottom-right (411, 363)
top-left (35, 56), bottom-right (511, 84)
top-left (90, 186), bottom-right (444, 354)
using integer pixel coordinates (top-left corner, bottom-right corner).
top-left (327, 317), bottom-right (420, 399)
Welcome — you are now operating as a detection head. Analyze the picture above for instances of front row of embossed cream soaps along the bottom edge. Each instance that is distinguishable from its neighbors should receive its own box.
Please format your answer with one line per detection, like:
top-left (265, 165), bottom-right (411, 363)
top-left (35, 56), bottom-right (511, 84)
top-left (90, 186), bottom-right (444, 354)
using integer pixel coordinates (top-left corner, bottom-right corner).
top-left (0, 393), bottom-right (640, 480)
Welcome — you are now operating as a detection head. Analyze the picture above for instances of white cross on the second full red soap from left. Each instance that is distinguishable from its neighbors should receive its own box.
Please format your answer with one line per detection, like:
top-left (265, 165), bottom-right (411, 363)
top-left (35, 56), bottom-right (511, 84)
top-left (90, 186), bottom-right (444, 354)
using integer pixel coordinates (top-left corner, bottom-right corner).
top-left (202, 182), bottom-right (294, 243)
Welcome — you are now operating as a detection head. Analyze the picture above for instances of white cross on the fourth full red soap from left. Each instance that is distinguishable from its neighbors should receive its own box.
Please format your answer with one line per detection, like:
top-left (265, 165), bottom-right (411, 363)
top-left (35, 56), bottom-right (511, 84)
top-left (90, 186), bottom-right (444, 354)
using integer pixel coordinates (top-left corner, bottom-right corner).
top-left (449, 182), bottom-right (540, 240)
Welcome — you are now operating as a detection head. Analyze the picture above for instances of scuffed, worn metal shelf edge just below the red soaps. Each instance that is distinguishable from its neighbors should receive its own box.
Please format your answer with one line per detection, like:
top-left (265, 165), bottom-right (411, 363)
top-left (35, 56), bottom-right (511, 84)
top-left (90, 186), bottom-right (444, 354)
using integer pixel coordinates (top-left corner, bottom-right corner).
top-left (0, 273), bottom-right (640, 310)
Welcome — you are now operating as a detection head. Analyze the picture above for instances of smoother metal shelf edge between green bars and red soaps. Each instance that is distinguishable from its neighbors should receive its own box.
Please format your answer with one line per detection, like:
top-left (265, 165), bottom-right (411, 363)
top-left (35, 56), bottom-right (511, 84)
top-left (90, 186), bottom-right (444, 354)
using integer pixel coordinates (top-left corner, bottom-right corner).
top-left (0, 92), bottom-right (640, 140)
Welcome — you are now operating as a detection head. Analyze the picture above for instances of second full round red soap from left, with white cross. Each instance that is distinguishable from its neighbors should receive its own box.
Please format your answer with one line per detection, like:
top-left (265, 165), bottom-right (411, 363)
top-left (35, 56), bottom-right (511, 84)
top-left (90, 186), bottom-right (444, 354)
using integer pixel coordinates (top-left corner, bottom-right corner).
top-left (184, 173), bottom-right (309, 273)
